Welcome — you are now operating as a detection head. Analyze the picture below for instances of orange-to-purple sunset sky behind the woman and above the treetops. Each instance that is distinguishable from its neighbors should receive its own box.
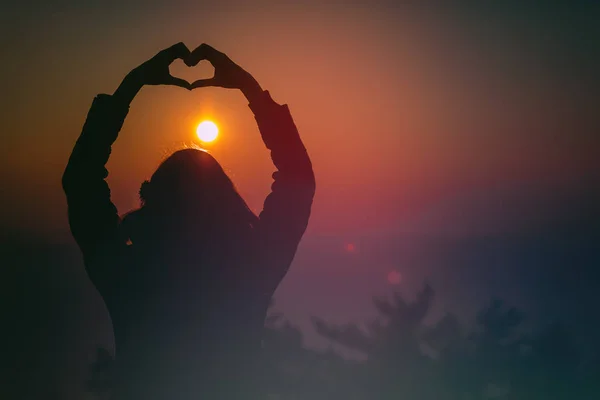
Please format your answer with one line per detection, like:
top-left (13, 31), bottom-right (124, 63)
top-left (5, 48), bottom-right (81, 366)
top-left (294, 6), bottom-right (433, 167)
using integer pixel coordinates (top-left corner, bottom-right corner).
top-left (0, 0), bottom-right (600, 398)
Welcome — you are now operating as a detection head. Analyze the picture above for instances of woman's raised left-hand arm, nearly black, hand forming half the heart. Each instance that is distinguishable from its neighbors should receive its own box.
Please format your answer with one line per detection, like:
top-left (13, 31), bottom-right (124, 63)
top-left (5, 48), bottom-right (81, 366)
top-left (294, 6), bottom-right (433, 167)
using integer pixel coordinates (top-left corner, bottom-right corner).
top-left (62, 44), bottom-right (189, 286)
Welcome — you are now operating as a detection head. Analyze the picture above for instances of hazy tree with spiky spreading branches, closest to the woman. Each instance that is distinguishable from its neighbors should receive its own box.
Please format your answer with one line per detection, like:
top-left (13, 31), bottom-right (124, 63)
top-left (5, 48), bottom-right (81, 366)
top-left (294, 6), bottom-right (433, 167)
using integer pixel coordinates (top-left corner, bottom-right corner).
top-left (313, 285), bottom-right (437, 400)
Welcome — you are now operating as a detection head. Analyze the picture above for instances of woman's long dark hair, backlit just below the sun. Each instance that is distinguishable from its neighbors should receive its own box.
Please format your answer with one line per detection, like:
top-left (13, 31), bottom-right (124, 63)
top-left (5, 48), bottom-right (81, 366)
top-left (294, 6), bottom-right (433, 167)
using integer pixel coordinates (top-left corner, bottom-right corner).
top-left (121, 149), bottom-right (257, 252)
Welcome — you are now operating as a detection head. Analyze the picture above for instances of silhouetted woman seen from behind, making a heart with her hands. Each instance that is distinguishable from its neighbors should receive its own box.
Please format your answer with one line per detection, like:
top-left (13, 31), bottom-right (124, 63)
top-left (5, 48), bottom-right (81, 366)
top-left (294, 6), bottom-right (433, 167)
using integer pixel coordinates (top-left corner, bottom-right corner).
top-left (63, 43), bottom-right (315, 399)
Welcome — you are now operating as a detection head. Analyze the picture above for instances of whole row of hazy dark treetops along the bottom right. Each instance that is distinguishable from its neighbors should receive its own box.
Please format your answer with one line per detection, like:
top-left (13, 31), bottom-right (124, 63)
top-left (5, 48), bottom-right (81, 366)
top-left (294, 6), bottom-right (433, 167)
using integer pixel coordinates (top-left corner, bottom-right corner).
top-left (313, 285), bottom-right (598, 400)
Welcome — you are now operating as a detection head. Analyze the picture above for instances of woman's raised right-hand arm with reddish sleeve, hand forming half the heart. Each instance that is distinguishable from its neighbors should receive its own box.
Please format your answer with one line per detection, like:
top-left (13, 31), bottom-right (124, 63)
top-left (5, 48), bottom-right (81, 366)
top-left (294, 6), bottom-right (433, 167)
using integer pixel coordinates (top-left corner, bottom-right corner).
top-left (186, 44), bottom-right (315, 283)
